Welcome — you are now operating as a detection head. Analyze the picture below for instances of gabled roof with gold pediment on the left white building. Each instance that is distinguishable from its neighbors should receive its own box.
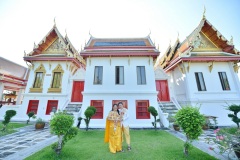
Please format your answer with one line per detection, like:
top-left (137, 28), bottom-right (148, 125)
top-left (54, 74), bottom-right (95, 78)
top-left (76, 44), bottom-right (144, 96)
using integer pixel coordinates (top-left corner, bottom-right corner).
top-left (24, 25), bottom-right (85, 68)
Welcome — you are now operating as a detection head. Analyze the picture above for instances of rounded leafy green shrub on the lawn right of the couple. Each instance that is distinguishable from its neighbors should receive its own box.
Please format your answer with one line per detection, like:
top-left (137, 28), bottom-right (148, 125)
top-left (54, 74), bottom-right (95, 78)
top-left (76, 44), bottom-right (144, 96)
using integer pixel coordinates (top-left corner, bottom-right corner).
top-left (175, 106), bottom-right (205, 155)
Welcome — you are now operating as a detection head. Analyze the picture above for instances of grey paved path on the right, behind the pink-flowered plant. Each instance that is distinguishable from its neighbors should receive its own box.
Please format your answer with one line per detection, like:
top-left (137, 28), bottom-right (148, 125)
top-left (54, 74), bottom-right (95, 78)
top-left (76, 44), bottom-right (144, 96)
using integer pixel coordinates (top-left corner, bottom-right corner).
top-left (167, 129), bottom-right (238, 160)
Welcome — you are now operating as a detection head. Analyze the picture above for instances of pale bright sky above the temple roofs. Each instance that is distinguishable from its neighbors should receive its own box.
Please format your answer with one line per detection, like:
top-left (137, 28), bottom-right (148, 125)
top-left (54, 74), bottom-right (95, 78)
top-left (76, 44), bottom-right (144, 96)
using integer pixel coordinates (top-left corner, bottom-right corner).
top-left (0, 0), bottom-right (240, 70)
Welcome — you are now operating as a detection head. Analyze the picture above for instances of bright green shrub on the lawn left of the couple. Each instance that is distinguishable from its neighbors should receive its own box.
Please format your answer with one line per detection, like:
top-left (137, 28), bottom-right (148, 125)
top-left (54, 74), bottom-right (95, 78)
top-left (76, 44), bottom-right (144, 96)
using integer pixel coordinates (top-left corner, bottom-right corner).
top-left (50, 111), bottom-right (78, 155)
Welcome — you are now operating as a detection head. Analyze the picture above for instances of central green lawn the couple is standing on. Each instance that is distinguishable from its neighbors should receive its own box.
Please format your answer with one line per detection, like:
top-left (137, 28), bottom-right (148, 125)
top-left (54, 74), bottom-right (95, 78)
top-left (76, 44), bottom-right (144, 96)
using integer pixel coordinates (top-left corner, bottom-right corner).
top-left (26, 130), bottom-right (215, 160)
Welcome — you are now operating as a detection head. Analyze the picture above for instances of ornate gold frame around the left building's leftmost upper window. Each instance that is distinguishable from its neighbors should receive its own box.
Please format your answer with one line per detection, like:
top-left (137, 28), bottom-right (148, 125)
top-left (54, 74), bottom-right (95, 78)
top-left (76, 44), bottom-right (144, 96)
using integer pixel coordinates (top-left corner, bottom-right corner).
top-left (29, 63), bottom-right (46, 93)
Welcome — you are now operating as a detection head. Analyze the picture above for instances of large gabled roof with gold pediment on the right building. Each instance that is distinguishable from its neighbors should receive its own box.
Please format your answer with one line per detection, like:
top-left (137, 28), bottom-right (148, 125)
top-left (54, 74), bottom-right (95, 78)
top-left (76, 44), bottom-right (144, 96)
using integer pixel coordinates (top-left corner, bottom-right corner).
top-left (158, 17), bottom-right (240, 71)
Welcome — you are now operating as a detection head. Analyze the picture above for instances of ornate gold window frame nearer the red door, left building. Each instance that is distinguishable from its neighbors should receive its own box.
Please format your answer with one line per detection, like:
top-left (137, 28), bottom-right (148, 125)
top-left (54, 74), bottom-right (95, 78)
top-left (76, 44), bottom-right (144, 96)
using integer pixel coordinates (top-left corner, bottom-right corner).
top-left (48, 64), bottom-right (64, 93)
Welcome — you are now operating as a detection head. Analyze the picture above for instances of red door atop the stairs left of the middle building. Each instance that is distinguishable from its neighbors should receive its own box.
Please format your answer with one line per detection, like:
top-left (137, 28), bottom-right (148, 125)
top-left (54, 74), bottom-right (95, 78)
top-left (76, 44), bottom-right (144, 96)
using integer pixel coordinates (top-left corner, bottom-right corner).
top-left (71, 81), bottom-right (84, 102)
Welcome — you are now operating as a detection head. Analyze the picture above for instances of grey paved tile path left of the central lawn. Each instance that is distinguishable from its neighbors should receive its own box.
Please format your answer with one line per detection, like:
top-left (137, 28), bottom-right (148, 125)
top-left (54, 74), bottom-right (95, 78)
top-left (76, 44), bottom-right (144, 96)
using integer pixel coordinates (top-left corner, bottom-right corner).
top-left (0, 125), bottom-right (57, 160)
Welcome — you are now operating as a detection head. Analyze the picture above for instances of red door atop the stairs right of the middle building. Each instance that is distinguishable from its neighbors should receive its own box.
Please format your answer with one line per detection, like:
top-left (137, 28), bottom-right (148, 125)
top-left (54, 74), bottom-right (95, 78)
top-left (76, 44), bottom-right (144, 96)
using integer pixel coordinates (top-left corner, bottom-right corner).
top-left (156, 80), bottom-right (170, 101)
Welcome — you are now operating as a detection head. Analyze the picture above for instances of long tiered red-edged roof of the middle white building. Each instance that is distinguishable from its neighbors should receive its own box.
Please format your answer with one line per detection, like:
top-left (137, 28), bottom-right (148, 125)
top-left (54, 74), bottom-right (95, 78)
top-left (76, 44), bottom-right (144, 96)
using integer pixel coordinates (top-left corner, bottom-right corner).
top-left (80, 36), bottom-right (159, 59)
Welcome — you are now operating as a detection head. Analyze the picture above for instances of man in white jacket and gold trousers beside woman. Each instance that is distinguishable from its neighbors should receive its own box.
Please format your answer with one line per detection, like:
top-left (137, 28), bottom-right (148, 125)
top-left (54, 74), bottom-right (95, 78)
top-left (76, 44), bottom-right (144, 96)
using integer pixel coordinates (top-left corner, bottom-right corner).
top-left (118, 102), bottom-right (131, 151)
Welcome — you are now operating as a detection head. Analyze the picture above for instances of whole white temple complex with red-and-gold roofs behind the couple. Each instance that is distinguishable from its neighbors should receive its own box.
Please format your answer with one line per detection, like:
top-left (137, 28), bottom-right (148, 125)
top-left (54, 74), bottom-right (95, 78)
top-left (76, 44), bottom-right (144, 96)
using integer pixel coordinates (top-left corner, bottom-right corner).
top-left (0, 16), bottom-right (240, 128)
